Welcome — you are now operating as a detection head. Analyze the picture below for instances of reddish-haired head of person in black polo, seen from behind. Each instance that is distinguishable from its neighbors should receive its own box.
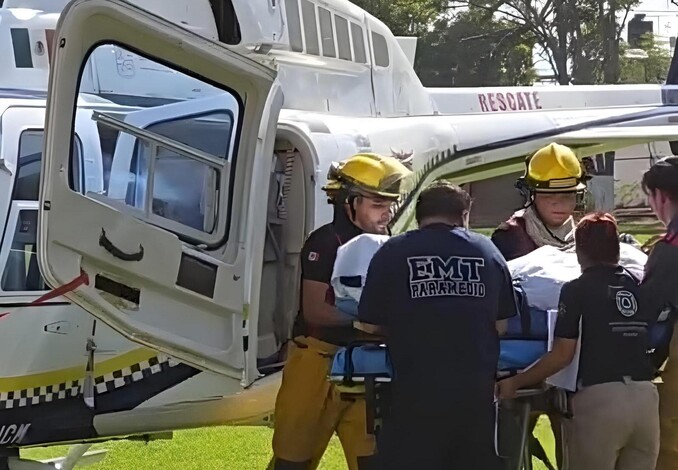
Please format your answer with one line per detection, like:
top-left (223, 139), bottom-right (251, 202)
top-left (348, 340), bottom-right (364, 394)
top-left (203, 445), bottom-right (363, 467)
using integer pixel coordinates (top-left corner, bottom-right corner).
top-left (574, 212), bottom-right (619, 269)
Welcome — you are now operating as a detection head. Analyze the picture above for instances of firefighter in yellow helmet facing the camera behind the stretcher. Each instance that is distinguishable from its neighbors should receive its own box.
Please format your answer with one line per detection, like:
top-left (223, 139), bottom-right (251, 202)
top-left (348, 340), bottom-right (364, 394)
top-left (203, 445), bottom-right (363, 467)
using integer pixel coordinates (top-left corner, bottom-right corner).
top-left (492, 143), bottom-right (589, 468)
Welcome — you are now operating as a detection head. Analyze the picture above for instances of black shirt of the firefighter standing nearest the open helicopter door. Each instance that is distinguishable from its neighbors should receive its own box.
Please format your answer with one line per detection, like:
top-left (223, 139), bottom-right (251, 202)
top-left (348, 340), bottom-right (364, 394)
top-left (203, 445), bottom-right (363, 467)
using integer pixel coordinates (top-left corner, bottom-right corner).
top-left (297, 206), bottom-right (362, 345)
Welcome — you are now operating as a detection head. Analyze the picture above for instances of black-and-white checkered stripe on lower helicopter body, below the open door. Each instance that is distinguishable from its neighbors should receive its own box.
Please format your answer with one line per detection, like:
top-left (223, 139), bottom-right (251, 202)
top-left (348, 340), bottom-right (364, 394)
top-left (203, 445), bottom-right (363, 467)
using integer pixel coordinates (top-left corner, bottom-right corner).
top-left (0, 354), bottom-right (179, 410)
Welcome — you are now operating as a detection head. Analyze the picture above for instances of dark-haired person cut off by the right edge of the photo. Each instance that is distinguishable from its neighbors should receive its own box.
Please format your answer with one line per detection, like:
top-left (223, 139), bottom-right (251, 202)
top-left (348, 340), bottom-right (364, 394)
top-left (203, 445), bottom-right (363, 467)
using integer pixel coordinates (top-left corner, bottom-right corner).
top-left (641, 157), bottom-right (678, 470)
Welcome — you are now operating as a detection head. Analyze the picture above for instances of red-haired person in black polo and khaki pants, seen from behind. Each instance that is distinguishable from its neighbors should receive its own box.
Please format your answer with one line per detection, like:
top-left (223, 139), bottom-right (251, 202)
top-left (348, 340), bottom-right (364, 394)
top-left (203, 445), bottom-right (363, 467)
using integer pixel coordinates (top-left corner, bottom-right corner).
top-left (498, 213), bottom-right (659, 470)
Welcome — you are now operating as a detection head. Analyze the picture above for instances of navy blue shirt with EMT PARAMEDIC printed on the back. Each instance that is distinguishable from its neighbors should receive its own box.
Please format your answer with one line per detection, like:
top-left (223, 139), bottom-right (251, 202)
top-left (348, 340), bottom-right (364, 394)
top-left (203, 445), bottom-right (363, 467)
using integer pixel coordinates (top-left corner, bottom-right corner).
top-left (359, 224), bottom-right (516, 393)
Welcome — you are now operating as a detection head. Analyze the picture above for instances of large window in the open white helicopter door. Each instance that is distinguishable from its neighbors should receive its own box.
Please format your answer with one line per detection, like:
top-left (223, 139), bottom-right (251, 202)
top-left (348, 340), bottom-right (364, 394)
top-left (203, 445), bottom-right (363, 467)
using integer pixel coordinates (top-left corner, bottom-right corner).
top-left (80, 45), bottom-right (243, 245)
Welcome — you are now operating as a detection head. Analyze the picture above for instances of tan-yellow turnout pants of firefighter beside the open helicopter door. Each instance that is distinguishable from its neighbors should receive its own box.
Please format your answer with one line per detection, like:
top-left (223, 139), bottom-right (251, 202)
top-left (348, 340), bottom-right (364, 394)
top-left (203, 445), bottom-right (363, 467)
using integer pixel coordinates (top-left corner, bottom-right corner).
top-left (272, 336), bottom-right (377, 470)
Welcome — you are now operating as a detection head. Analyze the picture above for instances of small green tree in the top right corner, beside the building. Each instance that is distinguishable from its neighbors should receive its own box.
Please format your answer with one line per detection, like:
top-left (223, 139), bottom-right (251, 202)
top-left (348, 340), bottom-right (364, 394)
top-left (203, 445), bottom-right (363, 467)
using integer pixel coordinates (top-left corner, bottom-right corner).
top-left (619, 34), bottom-right (671, 84)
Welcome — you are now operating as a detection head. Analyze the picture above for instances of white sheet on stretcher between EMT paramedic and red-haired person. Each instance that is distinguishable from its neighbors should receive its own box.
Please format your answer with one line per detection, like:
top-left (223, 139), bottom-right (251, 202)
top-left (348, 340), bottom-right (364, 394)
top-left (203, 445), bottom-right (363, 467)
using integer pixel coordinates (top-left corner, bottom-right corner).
top-left (508, 243), bottom-right (647, 391)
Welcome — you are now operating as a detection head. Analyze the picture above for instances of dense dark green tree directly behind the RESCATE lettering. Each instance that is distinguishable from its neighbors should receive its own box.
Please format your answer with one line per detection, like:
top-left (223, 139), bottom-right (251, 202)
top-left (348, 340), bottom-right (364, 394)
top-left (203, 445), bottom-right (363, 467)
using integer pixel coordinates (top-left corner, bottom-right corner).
top-left (415, 8), bottom-right (535, 86)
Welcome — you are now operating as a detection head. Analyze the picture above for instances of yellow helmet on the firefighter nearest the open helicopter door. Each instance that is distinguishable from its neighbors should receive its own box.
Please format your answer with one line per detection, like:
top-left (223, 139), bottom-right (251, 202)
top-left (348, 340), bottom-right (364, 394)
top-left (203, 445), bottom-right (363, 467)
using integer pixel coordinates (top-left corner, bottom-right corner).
top-left (322, 153), bottom-right (412, 199)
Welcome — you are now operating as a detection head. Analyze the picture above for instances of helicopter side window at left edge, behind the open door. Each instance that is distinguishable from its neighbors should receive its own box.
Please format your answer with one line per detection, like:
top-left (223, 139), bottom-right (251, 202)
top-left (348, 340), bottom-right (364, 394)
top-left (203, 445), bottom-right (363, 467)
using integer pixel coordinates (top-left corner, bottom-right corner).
top-left (0, 130), bottom-right (82, 292)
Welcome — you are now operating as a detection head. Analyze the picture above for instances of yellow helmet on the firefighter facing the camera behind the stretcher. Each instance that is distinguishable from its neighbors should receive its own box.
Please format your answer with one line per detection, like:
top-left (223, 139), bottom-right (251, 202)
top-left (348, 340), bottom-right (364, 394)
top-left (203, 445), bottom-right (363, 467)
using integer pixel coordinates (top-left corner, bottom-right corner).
top-left (522, 143), bottom-right (588, 193)
